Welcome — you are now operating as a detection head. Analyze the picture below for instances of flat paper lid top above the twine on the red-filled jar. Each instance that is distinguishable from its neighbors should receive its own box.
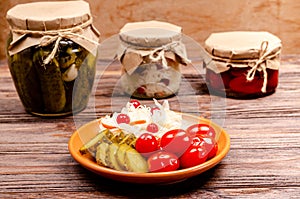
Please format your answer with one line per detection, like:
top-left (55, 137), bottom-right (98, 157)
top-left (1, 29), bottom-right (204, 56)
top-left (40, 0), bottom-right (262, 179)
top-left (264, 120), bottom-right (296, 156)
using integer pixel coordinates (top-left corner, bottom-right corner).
top-left (205, 31), bottom-right (281, 59)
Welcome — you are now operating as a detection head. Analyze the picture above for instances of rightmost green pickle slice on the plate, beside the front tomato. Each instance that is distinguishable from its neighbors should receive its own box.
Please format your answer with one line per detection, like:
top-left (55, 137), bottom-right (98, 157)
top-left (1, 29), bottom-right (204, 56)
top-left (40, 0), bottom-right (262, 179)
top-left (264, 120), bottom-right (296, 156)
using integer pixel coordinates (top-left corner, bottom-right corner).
top-left (125, 148), bottom-right (149, 173)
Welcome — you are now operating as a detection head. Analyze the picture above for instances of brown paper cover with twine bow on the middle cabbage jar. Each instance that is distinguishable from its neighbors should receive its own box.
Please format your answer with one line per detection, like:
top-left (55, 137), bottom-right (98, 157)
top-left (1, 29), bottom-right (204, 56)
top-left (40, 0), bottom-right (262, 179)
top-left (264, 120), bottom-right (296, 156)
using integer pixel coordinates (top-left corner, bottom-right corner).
top-left (117, 21), bottom-right (191, 74)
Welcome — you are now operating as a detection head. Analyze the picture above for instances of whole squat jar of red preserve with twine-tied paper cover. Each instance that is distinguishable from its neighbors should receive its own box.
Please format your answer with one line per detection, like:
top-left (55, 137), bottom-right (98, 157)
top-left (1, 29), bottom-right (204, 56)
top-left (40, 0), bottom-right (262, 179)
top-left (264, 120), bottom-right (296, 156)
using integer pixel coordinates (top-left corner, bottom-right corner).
top-left (205, 31), bottom-right (282, 98)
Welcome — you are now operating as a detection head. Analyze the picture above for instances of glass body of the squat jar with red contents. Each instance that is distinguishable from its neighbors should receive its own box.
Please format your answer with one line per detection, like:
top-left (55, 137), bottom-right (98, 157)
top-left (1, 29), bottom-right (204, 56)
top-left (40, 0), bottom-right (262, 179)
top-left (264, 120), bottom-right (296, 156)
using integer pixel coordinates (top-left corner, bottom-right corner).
top-left (206, 64), bottom-right (278, 98)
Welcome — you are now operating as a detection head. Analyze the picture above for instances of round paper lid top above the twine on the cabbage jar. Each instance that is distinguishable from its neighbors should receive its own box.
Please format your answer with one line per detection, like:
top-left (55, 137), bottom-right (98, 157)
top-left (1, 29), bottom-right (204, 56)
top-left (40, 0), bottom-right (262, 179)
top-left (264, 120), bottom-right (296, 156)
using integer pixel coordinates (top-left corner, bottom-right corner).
top-left (119, 21), bottom-right (182, 48)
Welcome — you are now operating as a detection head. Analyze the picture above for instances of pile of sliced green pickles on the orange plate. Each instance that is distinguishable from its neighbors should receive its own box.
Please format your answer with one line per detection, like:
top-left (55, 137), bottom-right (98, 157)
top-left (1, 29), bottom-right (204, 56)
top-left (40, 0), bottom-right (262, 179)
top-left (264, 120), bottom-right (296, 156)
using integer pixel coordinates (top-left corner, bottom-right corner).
top-left (79, 129), bottom-right (148, 173)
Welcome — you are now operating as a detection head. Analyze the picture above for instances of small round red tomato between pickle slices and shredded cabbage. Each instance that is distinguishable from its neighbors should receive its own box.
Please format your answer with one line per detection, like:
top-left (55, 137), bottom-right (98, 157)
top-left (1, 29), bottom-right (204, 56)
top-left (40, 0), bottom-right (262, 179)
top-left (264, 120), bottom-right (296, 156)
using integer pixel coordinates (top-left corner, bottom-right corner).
top-left (135, 133), bottom-right (159, 156)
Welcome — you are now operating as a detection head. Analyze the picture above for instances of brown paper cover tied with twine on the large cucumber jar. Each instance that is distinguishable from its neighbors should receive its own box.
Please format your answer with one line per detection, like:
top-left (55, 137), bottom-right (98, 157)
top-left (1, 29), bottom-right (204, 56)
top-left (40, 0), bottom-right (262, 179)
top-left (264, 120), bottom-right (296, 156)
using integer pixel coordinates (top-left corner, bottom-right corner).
top-left (6, 1), bottom-right (100, 64)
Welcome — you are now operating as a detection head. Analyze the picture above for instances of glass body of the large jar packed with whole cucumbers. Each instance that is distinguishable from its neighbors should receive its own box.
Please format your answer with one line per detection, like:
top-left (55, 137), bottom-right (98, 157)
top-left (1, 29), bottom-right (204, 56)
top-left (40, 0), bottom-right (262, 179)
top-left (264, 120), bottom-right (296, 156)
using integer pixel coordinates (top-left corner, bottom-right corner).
top-left (8, 36), bottom-right (96, 117)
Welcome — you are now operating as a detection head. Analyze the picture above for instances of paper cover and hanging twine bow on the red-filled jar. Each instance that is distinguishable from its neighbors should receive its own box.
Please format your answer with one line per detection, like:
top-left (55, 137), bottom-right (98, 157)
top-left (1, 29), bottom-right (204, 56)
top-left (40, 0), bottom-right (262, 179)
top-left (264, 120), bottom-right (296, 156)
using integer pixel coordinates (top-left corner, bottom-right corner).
top-left (205, 31), bottom-right (282, 93)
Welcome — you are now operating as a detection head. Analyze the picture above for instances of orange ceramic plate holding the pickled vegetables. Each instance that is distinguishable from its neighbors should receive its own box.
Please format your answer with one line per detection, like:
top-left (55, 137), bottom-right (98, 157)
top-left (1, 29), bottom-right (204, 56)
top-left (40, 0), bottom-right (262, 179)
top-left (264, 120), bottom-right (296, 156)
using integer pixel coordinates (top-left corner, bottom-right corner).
top-left (69, 114), bottom-right (230, 184)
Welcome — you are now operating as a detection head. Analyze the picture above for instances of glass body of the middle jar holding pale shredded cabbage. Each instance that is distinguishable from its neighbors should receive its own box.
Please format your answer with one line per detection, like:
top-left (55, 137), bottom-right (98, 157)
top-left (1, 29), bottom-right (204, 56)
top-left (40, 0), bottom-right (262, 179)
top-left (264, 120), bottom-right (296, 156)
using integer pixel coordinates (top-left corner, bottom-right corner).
top-left (121, 59), bottom-right (181, 99)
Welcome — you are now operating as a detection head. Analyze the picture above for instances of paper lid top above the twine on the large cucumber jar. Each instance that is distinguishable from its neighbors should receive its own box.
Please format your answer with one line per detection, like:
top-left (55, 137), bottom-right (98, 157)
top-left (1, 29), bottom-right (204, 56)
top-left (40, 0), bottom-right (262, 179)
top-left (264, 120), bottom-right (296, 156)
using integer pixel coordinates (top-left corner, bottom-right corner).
top-left (7, 1), bottom-right (91, 31)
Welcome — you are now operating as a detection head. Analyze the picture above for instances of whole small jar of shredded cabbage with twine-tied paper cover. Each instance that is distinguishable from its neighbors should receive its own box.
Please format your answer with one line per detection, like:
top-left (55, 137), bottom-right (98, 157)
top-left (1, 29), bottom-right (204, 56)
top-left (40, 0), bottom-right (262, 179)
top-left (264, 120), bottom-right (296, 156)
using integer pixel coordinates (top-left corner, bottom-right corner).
top-left (118, 21), bottom-right (189, 99)
